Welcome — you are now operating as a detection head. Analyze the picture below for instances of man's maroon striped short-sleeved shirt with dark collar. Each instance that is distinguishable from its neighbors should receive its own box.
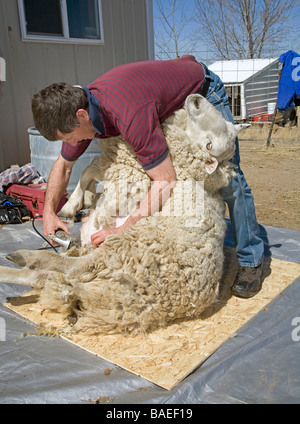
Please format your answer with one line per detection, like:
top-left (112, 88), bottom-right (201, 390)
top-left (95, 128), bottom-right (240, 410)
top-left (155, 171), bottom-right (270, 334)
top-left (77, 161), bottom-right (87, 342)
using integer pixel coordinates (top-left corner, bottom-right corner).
top-left (61, 55), bottom-right (204, 170)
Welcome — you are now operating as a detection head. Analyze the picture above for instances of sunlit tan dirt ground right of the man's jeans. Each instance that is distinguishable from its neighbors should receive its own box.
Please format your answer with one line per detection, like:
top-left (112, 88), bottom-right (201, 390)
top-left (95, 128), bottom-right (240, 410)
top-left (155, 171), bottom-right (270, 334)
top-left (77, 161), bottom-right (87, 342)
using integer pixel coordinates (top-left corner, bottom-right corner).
top-left (239, 127), bottom-right (300, 230)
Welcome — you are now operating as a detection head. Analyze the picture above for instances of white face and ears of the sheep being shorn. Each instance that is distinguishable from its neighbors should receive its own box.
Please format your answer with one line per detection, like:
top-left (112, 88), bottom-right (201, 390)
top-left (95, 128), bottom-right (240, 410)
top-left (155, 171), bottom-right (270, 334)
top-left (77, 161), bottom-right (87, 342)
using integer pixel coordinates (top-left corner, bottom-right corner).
top-left (185, 94), bottom-right (245, 174)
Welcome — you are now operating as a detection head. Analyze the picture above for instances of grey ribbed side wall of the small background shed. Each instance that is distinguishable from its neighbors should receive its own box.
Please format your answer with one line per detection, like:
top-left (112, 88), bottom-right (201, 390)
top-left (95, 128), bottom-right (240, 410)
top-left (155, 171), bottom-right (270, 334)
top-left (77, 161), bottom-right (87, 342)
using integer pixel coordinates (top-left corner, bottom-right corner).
top-left (244, 60), bottom-right (279, 118)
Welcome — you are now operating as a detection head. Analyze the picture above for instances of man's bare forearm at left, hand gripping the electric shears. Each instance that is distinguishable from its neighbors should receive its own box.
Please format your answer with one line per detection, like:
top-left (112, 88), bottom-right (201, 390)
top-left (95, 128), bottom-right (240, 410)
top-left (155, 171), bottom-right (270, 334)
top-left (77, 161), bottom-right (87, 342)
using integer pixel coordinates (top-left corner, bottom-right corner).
top-left (43, 155), bottom-right (75, 237)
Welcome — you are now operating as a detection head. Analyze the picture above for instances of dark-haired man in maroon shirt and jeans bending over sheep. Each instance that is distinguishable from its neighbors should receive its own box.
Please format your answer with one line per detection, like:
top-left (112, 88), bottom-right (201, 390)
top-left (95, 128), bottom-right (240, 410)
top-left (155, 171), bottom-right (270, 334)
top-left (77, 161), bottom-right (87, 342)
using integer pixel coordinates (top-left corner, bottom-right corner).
top-left (32, 55), bottom-right (264, 297)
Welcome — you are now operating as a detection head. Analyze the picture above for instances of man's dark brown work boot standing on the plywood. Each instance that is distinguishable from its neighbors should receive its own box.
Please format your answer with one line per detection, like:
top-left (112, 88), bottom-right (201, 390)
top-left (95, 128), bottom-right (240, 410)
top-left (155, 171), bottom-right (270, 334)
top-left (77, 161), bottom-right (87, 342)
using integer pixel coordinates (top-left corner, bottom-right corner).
top-left (231, 263), bottom-right (263, 298)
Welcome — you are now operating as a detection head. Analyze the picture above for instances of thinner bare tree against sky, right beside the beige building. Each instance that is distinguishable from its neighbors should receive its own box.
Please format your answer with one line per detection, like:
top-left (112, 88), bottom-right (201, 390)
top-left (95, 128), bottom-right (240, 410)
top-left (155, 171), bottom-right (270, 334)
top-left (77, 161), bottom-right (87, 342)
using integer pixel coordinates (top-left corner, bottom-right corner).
top-left (154, 0), bottom-right (195, 59)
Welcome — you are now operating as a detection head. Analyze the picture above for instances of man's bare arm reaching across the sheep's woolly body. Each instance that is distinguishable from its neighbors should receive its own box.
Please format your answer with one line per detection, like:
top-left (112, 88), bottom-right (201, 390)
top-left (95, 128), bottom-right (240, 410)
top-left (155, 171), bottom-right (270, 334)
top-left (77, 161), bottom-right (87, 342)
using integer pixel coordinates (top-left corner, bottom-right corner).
top-left (91, 155), bottom-right (176, 247)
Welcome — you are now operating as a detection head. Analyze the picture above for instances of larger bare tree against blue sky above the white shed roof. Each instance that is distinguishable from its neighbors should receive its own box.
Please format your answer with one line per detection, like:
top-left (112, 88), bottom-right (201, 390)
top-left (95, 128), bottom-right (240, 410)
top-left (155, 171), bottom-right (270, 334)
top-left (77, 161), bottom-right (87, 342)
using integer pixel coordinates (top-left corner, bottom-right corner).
top-left (195, 0), bottom-right (296, 60)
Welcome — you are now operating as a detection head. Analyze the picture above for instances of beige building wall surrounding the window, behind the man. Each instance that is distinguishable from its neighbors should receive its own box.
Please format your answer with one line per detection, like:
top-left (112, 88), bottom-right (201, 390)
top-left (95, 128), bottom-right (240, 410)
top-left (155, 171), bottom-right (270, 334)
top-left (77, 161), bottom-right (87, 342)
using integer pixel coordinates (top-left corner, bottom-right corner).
top-left (0, 0), bottom-right (149, 172)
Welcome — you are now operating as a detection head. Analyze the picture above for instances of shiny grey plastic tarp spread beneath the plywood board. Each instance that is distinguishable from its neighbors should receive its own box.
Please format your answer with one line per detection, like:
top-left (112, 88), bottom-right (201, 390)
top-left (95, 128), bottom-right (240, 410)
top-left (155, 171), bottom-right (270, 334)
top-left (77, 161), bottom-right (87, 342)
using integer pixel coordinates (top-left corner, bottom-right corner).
top-left (0, 222), bottom-right (300, 405)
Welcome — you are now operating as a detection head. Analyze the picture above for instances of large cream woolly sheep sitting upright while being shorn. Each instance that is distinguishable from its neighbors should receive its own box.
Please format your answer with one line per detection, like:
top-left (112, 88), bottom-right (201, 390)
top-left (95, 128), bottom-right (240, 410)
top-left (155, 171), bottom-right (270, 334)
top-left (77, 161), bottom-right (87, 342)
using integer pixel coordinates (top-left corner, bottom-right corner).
top-left (0, 94), bottom-right (247, 334)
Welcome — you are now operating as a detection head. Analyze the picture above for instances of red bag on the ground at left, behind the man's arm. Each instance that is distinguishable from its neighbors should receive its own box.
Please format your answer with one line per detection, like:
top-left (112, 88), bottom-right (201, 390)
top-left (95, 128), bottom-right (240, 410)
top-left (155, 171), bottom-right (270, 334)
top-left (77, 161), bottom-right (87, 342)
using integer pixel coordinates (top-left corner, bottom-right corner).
top-left (5, 183), bottom-right (68, 217)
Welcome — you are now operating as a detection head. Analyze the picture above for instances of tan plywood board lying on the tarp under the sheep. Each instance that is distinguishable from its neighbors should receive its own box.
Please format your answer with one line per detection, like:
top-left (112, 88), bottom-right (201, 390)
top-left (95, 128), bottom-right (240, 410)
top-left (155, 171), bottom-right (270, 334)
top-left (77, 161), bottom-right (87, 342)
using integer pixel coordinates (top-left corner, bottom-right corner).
top-left (5, 248), bottom-right (300, 390)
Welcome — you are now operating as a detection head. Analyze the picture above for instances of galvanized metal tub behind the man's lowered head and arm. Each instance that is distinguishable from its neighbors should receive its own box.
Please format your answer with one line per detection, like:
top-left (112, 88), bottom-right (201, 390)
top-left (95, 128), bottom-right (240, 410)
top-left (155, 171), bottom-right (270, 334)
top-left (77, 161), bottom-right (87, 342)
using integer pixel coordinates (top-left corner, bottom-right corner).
top-left (27, 127), bottom-right (101, 194)
